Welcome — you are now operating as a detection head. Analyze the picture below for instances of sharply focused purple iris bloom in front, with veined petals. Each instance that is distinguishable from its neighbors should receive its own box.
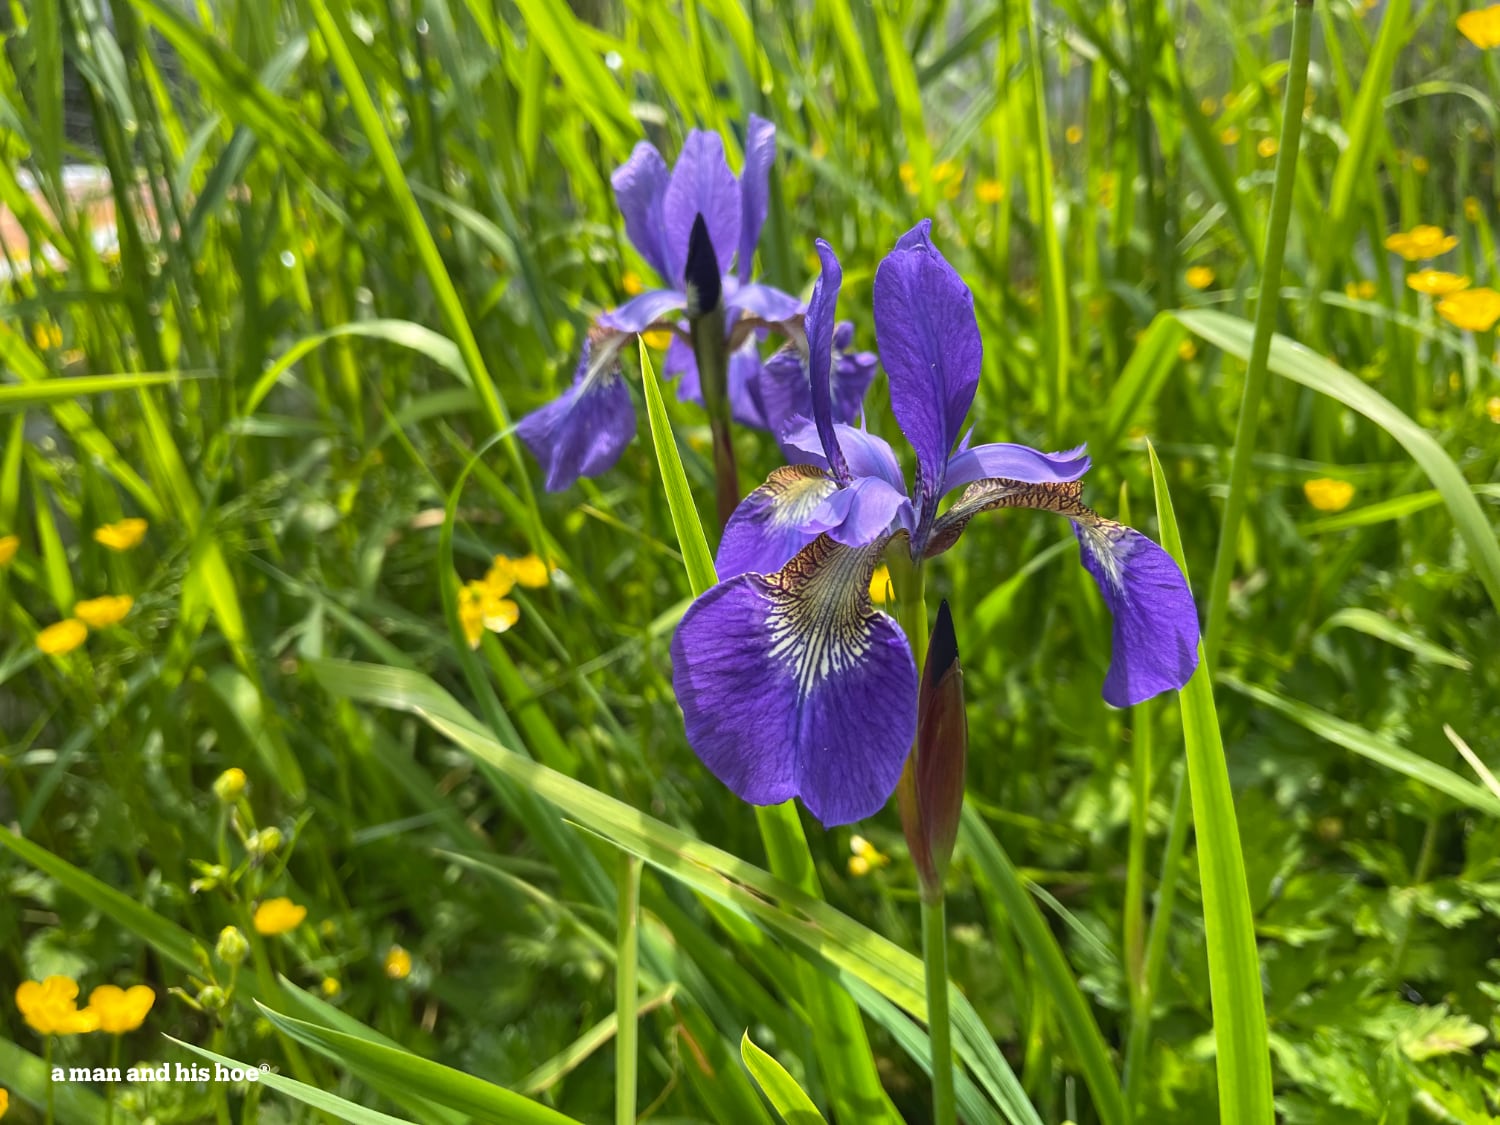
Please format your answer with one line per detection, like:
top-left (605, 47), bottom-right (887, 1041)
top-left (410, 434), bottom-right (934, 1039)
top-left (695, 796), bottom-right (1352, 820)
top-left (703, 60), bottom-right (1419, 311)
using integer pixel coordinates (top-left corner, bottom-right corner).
top-left (672, 221), bottom-right (1199, 825)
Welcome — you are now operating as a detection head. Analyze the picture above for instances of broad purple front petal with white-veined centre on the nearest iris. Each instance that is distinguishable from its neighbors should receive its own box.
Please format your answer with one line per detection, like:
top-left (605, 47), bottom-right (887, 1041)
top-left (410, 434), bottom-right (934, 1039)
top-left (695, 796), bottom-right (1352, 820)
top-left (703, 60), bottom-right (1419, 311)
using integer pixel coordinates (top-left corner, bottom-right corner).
top-left (672, 537), bottom-right (917, 827)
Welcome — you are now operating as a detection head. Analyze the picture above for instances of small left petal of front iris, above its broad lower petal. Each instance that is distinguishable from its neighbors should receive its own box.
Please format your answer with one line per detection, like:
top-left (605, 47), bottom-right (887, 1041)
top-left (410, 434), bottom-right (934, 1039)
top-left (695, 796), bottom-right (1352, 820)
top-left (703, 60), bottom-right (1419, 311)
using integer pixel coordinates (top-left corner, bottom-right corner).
top-left (714, 465), bottom-right (839, 581)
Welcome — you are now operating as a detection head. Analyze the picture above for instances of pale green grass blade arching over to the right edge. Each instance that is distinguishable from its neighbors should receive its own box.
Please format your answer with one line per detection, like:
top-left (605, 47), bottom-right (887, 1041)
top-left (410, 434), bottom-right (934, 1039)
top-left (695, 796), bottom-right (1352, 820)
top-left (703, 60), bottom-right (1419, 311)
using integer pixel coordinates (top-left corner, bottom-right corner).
top-left (1175, 309), bottom-right (1500, 609)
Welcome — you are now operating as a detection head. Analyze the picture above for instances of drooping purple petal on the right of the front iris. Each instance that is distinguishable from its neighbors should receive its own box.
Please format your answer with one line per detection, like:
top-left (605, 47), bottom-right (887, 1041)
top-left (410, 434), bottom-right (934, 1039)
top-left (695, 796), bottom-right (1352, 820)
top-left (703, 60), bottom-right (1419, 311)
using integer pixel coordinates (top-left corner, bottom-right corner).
top-left (1073, 519), bottom-right (1199, 707)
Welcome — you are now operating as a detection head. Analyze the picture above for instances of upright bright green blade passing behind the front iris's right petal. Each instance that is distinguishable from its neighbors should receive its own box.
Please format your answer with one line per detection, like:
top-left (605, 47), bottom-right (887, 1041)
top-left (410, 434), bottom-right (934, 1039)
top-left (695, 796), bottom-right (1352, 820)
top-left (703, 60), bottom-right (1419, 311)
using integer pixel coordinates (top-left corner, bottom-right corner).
top-left (1151, 449), bottom-right (1277, 1125)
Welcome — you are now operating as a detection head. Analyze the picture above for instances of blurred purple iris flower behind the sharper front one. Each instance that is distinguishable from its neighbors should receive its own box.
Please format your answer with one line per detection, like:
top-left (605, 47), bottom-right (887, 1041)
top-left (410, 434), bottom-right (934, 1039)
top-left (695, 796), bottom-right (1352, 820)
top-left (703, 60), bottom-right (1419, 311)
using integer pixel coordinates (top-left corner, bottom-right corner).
top-left (528, 116), bottom-right (801, 492)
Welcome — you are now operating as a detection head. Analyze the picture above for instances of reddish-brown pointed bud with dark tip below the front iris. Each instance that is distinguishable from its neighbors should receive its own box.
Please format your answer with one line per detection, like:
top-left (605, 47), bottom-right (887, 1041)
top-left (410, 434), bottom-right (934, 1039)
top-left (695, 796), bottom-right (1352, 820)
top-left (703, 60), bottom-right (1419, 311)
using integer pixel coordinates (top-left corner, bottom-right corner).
top-left (900, 600), bottom-right (969, 903)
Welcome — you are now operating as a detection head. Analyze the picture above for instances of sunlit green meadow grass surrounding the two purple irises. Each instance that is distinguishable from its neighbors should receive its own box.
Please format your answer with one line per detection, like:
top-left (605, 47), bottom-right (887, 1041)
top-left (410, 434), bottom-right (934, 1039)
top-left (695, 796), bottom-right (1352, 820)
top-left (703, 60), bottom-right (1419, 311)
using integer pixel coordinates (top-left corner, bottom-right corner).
top-left (0, 0), bottom-right (1500, 1125)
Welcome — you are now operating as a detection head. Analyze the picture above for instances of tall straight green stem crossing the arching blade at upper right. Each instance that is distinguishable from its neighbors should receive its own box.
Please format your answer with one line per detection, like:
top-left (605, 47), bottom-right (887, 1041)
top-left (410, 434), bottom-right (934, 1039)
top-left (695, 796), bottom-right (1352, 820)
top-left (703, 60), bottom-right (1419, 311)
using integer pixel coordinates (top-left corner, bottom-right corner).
top-left (1203, 0), bottom-right (1313, 669)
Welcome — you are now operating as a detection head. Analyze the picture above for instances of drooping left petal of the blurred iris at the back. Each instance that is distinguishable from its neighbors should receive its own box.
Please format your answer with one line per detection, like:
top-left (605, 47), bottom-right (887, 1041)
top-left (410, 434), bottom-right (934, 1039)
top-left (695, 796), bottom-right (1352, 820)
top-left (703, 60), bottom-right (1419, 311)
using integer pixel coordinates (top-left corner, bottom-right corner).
top-left (516, 338), bottom-right (636, 492)
